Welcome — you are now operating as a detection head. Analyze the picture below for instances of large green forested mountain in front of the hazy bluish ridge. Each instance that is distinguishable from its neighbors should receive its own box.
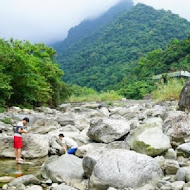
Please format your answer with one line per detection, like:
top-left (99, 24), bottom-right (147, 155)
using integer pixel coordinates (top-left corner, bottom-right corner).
top-left (55, 4), bottom-right (190, 91)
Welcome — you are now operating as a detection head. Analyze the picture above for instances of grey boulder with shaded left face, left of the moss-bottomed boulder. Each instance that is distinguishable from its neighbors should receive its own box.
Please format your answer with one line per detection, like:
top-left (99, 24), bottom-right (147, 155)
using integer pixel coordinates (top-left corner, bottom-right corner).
top-left (87, 118), bottom-right (130, 143)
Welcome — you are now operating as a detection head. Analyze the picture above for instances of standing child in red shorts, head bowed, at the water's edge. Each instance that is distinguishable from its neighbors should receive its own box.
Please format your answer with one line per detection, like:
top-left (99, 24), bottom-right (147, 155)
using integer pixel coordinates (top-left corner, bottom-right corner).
top-left (14, 117), bottom-right (29, 163)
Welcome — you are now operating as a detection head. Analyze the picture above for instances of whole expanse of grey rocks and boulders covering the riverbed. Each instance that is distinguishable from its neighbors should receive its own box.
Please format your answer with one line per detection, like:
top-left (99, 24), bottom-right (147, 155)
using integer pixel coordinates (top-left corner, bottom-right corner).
top-left (0, 100), bottom-right (190, 190)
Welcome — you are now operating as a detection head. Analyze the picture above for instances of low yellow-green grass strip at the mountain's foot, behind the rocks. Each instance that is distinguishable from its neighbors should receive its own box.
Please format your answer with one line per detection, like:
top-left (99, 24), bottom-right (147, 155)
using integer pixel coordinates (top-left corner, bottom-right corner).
top-left (69, 90), bottom-right (122, 102)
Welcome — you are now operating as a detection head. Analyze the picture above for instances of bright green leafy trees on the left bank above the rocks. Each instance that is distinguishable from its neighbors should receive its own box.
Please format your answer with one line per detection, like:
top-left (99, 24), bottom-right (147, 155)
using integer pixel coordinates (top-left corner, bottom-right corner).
top-left (0, 39), bottom-right (70, 106)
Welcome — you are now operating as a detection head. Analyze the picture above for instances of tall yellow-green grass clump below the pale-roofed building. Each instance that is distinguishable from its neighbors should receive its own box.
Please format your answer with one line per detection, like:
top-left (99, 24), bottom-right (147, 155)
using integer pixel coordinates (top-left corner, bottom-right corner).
top-left (152, 79), bottom-right (185, 101)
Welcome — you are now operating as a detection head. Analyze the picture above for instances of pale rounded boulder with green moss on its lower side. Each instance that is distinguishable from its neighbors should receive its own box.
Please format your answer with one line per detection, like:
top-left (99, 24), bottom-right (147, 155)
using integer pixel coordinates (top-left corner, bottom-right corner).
top-left (129, 125), bottom-right (171, 156)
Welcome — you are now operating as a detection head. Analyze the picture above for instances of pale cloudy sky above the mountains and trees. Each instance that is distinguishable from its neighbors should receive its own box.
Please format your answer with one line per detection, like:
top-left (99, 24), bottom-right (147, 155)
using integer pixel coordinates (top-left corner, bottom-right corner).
top-left (0, 0), bottom-right (190, 43)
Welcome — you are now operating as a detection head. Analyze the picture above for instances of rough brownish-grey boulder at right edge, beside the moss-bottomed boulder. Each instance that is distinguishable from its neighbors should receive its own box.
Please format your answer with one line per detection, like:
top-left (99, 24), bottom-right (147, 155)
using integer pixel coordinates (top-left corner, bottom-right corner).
top-left (162, 111), bottom-right (190, 146)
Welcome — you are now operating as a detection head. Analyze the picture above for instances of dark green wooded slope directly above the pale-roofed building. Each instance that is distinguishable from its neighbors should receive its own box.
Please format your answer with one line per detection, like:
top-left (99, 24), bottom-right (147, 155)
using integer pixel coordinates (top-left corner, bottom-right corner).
top-left (137, 35), bottom-right (190, 78)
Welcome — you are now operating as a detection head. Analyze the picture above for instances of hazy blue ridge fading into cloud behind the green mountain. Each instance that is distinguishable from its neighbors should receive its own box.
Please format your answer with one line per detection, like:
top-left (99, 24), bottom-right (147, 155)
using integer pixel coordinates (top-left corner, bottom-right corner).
top-left (52, 0), bottom-right (133, 54)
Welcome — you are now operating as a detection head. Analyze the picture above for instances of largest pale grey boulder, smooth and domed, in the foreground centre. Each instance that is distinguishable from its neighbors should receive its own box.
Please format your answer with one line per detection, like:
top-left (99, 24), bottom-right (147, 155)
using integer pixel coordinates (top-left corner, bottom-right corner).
top-left (90, 150), bottom-right (163, 190)
